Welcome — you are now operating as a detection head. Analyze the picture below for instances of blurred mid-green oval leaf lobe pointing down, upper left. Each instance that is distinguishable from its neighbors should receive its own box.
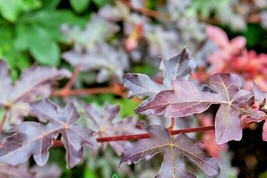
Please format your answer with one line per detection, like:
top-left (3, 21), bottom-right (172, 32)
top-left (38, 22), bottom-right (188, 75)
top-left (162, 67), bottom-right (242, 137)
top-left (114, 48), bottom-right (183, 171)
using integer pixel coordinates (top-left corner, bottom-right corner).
top-left (29, 27), bottom-right (60, 66)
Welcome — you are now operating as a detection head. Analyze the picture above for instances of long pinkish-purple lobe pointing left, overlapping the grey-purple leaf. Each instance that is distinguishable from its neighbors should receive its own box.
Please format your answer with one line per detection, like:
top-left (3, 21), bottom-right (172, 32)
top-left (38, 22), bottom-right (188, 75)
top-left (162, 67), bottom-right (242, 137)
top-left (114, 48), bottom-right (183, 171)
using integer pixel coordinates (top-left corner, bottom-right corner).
top-left (136, 80), bottom-right (221, 117)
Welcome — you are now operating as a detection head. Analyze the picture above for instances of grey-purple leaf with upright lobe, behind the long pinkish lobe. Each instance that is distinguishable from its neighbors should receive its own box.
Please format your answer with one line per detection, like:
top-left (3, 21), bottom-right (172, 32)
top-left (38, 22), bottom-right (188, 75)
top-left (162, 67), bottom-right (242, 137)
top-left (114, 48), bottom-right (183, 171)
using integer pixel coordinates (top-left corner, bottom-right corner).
top-left (123, 49), bottom-right (195, 105)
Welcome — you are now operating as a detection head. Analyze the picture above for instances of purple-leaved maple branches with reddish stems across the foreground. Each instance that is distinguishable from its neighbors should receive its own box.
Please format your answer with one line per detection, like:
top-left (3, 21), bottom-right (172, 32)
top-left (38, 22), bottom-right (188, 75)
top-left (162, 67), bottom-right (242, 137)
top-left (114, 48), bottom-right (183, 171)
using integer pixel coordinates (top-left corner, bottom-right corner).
top-left (0, 49), bottom-right (267, 178)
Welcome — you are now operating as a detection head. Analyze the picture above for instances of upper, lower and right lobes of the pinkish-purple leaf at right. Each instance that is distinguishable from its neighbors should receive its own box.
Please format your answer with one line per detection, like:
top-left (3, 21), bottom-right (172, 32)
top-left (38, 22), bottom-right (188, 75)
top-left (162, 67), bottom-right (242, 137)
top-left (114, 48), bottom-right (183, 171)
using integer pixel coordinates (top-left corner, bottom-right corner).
top-left (210, 74), bottom-right (253, 144)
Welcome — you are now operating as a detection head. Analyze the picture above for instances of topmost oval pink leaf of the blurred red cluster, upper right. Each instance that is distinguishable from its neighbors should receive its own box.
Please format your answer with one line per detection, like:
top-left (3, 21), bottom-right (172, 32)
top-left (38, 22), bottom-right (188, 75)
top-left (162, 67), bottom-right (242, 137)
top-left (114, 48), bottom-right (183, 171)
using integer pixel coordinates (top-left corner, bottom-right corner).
top-left (206, 25), bottom-right (229, 48)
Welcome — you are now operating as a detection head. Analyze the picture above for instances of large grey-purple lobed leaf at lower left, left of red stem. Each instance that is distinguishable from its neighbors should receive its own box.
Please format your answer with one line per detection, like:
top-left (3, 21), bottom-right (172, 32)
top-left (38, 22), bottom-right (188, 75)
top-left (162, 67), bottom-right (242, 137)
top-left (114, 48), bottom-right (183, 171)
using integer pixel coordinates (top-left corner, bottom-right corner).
top-left (0, 99), bottom-right (96, 168)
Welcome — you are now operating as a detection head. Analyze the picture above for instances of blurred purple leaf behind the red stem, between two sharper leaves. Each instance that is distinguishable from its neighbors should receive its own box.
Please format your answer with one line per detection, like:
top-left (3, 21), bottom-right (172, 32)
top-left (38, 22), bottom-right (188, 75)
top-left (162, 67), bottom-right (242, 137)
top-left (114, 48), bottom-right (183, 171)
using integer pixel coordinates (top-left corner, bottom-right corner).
top-left (85, 105), bottom-right (144, 155)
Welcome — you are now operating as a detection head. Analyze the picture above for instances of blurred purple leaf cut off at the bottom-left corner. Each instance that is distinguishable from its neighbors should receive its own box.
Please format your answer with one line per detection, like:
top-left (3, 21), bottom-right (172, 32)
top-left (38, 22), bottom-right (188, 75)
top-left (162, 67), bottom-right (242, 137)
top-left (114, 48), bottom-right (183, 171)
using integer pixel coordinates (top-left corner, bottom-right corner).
top-left (0, 163), bottom-right (36, 178)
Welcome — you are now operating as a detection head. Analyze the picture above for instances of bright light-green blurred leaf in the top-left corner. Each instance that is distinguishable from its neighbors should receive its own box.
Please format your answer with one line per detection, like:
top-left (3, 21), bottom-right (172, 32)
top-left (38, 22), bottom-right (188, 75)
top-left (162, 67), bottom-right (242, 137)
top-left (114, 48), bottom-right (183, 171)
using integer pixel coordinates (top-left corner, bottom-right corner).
top-left (0, 0), bottom-right (41, 22)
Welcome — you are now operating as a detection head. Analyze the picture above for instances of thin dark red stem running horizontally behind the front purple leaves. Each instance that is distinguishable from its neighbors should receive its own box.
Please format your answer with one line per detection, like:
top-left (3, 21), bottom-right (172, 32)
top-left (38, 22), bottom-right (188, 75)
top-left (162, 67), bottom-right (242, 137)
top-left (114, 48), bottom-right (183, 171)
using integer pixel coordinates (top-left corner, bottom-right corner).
top-left (53, 126), bottom-right (214, 147)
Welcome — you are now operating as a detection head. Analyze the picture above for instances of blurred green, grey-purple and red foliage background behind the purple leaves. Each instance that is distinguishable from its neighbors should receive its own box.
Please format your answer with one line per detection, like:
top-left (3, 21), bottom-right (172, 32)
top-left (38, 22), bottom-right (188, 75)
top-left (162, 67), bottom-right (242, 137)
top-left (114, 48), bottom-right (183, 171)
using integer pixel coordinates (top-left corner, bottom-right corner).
top-left (0, 0), bottom-right (267, 178)
